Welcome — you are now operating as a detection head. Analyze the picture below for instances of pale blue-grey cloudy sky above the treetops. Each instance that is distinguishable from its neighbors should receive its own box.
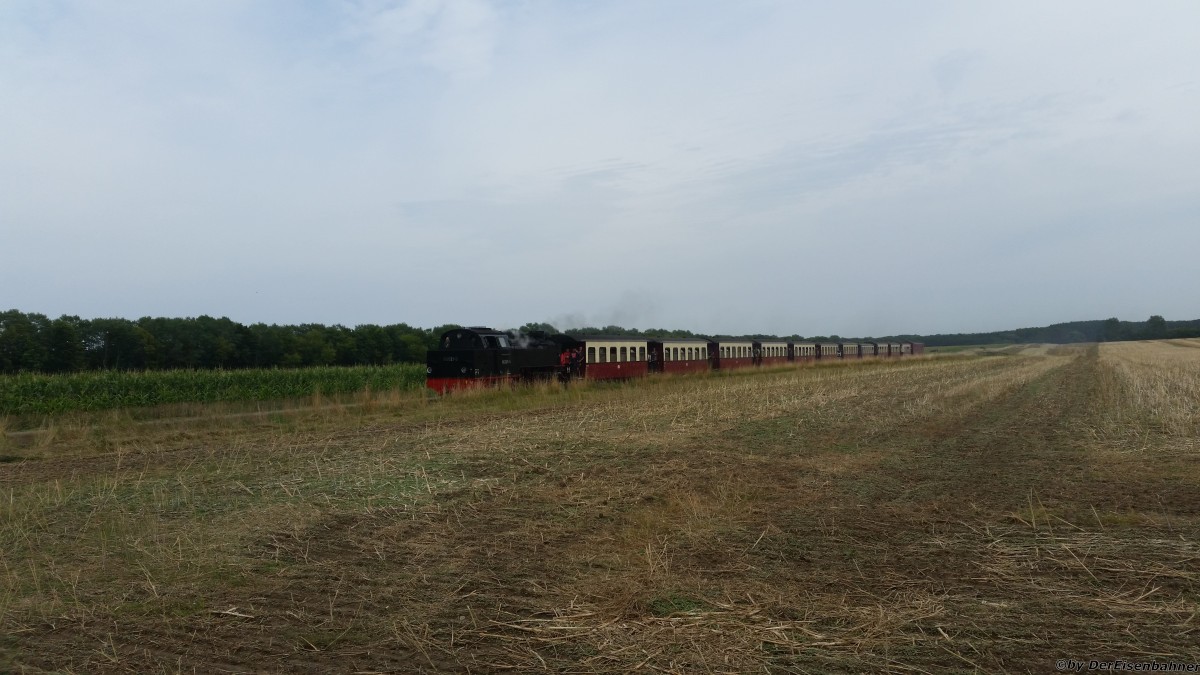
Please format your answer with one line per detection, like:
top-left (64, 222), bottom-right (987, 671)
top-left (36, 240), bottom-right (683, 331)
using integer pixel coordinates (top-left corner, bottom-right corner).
top-left (0, 0), bottom-right (1200, 336)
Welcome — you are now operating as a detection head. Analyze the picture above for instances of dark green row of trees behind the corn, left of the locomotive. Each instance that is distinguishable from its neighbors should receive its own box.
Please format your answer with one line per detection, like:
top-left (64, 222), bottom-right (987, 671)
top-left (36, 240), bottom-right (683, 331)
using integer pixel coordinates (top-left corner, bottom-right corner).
top-left (0, 310), bottom-right (455, 374)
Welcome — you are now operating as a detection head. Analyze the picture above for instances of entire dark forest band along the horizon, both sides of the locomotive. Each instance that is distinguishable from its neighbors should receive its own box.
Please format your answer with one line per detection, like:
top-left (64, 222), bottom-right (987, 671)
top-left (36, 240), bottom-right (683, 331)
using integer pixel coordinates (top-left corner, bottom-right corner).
top-left (0, 310), bottom-right (1200, 374)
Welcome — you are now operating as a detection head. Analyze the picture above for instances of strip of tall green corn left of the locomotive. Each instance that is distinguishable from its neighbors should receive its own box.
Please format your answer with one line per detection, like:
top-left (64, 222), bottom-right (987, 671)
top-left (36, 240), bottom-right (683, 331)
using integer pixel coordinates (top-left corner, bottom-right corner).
top-left (0, 364), bottom-right (425, 416)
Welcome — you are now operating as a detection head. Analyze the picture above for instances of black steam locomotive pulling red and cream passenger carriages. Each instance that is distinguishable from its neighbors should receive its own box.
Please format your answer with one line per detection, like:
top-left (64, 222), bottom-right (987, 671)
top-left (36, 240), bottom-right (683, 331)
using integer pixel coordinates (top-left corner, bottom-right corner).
top-left (426, 327), bottom-right (925, 394)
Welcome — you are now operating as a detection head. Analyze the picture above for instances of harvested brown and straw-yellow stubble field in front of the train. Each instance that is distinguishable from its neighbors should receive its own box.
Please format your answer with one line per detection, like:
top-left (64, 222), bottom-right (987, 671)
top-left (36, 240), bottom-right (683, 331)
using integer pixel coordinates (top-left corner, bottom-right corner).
top-left (0, 341), bottom-right (1200, 673)
